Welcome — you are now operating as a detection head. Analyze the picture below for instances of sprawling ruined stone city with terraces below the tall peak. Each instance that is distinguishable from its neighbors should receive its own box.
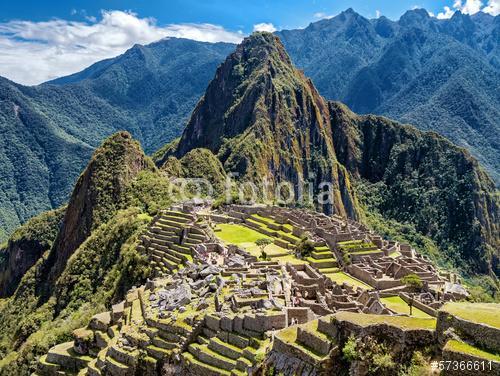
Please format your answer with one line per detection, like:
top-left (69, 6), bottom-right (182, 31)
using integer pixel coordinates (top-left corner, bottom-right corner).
top-left (37, 206), bottom-right (480, 376)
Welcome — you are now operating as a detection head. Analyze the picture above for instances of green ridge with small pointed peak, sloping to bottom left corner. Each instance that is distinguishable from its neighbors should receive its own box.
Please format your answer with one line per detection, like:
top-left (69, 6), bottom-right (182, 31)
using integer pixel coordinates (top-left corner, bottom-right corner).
top-left (0, 132), bottom-right (174, 375)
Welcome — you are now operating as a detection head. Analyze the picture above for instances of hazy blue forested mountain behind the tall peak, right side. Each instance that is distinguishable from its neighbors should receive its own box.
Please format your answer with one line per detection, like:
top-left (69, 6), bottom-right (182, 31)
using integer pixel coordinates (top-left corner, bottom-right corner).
top-left (277, 9), bottom-right (500, 182)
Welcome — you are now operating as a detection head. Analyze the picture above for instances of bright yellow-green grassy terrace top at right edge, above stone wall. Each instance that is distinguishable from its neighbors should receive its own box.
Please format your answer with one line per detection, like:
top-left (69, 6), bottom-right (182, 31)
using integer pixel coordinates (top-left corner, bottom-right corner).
top-left (441, 303), bottom-right (500, 328)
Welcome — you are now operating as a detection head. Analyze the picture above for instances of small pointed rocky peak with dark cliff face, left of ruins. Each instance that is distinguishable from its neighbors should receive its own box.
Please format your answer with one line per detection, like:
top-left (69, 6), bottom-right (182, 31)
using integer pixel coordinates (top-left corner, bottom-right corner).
top-left (41, 132), bottom-right (152, 288)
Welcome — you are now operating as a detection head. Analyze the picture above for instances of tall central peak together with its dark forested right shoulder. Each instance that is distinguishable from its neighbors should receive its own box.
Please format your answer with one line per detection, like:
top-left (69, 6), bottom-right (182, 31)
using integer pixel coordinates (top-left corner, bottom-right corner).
top-left (159, 33), bottom-right (500, 275)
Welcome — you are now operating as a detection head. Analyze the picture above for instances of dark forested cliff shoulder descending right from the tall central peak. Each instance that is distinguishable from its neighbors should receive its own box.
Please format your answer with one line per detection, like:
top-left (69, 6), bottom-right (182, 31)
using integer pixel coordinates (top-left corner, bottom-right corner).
top-left (330, 102), bottom-right (500, 275)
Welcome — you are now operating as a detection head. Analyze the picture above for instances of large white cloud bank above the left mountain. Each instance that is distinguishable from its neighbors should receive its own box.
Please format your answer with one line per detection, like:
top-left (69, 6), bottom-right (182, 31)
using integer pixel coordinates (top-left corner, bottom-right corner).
top-left (0, 10), bottom-right (244, 85)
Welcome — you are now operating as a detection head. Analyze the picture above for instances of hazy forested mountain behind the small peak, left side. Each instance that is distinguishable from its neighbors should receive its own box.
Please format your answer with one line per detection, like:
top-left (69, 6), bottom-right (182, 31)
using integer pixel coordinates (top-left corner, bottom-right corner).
top-left (0, 39), bottom-right (234, 240)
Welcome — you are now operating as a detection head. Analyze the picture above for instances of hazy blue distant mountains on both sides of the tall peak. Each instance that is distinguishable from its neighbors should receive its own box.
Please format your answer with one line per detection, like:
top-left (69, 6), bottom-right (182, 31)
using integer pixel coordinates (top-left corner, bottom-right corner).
top-left (0, 10), bottom-right (500, 239)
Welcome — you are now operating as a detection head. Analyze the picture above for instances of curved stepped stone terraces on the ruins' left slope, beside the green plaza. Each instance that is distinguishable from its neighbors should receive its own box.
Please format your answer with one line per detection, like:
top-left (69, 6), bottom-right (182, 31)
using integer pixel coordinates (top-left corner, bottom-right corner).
top-left (138, 210), bottom-right (207, 277)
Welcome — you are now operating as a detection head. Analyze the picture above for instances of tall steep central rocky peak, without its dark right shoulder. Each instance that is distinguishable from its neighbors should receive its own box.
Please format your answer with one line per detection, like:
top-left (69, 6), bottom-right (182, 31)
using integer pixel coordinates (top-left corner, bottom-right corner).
top-left (176, 33), bottom-right (358, 218)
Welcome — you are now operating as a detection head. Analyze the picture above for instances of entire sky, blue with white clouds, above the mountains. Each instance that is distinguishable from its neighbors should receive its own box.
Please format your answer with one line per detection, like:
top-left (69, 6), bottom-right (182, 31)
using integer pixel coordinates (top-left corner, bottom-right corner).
top-left (0, 0), bottom-right (500, 85)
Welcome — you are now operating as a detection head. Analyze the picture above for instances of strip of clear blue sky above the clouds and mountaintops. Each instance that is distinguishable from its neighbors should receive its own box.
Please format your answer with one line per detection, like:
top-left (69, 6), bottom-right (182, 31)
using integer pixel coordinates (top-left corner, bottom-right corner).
top-left (0, 0), bottom-right (453, 28)
